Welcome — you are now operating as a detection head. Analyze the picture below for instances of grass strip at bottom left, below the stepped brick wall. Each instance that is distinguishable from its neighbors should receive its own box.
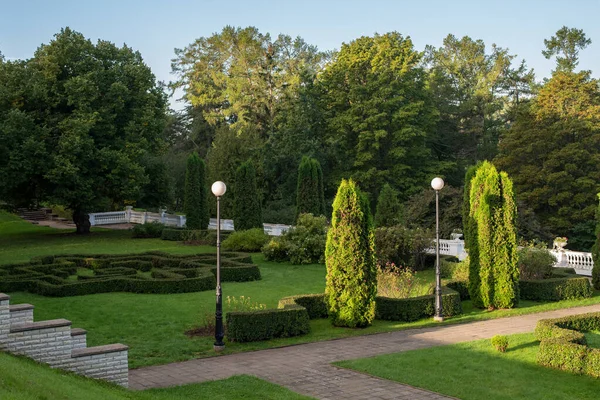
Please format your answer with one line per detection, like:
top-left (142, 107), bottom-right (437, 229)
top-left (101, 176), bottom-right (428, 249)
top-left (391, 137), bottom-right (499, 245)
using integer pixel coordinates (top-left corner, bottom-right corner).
top-left (0, 353), bottom-right (309, 400)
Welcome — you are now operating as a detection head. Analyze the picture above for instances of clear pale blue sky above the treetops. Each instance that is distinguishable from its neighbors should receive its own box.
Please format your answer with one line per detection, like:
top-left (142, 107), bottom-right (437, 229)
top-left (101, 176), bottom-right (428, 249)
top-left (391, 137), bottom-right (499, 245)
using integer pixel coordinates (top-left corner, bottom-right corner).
top-left (0, 0), bottom-right (600, 108)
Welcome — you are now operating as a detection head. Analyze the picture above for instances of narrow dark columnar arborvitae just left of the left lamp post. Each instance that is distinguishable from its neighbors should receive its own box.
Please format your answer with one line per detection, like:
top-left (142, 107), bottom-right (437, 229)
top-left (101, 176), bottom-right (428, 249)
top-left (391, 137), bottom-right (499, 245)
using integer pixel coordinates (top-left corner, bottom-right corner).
top-left (183, 152), bottom-right (209, 229)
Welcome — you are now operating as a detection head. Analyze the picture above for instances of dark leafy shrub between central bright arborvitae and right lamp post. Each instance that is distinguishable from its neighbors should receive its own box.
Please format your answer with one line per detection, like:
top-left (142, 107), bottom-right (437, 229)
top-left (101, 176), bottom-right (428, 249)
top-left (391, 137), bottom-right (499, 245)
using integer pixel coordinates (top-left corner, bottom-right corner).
top-left (375, 225), bottom-right (435, 271)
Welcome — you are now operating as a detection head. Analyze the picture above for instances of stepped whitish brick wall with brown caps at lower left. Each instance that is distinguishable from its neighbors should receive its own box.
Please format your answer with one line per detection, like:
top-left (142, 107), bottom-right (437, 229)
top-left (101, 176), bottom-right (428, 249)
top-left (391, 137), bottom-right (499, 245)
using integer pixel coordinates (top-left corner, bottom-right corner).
top-left (0, 293), bottom-right (129, 387)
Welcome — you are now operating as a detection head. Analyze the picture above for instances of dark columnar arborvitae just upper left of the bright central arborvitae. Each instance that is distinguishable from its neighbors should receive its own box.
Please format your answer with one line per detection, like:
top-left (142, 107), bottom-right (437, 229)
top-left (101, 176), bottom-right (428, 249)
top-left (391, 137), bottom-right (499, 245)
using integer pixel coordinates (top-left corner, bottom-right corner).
top-left (296, 156), bottom-right (325, 218)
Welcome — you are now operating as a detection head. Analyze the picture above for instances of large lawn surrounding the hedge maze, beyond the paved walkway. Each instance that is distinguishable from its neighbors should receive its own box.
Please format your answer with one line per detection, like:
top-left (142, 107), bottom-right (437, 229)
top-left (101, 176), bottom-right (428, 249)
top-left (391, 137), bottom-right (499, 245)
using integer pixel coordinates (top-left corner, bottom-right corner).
top-left (0, 213), bottom-right (600, 368)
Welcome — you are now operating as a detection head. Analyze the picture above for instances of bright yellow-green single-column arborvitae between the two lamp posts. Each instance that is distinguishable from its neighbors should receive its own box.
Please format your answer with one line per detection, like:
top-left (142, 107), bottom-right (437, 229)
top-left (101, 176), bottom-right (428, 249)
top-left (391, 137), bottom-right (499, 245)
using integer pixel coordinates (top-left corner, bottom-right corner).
top-left (325, 179), bottom-right (377, 328)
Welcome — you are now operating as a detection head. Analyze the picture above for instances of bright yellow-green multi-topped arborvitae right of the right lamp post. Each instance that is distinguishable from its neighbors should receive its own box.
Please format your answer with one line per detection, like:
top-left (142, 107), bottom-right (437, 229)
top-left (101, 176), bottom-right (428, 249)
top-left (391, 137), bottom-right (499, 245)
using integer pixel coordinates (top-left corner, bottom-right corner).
top-left (469, 161), bottom-right (519, 308)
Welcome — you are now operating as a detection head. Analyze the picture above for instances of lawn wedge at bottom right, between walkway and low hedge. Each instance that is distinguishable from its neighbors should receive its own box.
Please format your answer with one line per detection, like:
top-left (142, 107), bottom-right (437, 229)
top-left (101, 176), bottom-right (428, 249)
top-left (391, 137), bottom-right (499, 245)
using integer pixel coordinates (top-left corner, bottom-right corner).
top-left (336, 334), bottom-right (600, 400)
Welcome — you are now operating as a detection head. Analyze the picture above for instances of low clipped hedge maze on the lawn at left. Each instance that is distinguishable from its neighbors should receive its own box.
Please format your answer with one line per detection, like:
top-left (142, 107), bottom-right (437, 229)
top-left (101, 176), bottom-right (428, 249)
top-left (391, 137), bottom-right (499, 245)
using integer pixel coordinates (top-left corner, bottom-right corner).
top-left (0, 252), bottom-right (261, 297)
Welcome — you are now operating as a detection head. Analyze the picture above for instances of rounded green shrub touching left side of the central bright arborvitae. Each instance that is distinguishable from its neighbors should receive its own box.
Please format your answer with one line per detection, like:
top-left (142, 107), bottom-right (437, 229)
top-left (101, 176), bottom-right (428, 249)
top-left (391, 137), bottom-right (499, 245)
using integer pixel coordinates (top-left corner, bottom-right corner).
top-left (262, 214), bottom-right (327, 264)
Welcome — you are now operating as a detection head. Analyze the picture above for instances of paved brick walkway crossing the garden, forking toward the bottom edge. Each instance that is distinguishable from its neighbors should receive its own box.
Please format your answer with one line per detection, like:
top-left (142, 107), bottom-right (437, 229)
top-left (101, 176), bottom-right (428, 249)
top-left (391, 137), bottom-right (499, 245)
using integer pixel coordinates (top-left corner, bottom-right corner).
top-left (129, 304), bottom-right (600, 400)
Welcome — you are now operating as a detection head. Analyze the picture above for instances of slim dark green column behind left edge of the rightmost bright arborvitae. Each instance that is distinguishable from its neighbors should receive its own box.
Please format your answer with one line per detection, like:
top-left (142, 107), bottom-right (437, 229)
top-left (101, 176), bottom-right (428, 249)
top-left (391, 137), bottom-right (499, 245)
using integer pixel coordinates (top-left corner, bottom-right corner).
top-left (462, 163), bottom-right (483, 307)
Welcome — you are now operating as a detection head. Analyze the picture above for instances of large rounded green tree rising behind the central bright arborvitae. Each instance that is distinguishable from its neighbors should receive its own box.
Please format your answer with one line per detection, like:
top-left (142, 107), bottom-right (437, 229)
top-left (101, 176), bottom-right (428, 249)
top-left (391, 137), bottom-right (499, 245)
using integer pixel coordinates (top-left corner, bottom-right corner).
top-left (319, 32), bottom-right (438, 200)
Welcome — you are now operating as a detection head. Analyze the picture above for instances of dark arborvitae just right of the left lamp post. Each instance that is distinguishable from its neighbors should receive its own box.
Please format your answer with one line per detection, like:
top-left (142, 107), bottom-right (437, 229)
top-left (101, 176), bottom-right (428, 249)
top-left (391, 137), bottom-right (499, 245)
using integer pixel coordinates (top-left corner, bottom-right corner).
top-left (233, 161), bottom-right (263, 231)
